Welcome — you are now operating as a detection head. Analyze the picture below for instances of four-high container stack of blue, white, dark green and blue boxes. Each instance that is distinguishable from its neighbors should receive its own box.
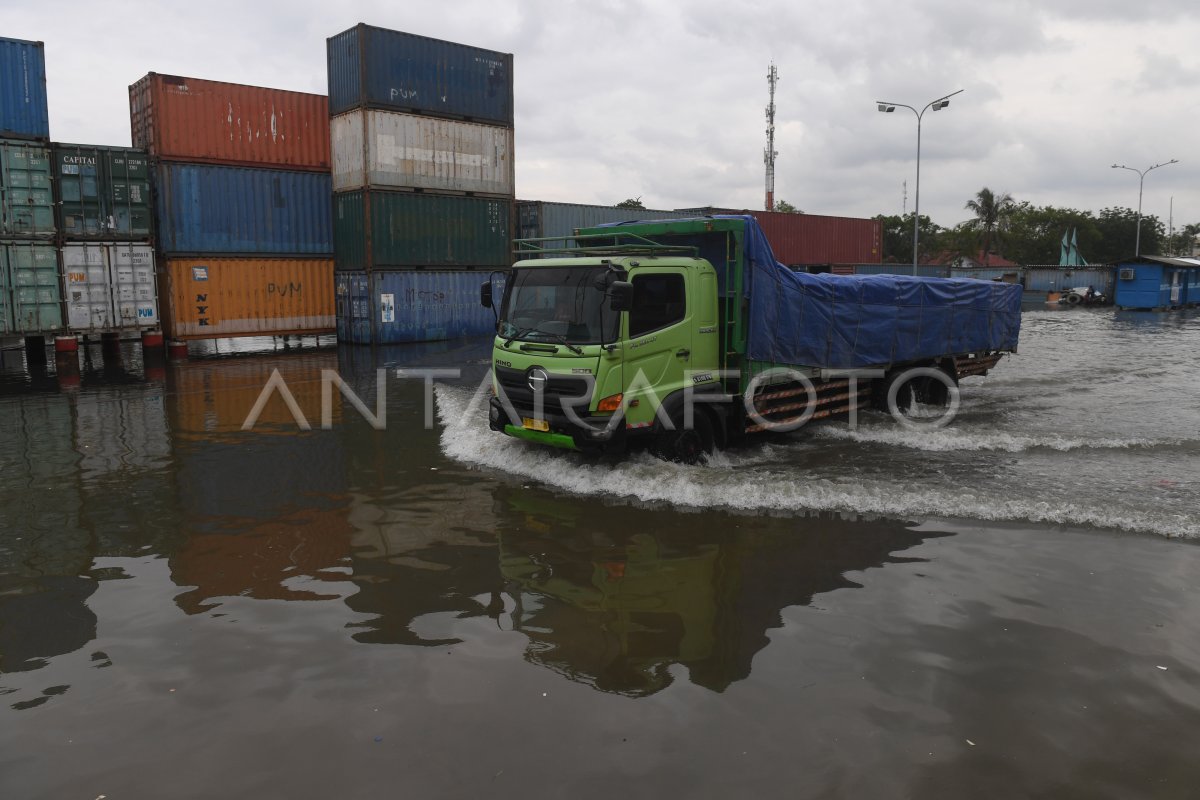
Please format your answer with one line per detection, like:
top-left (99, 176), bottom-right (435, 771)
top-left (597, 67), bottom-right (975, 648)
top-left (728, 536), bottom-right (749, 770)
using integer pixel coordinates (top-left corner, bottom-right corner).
top-left (328, 24), bottom-right (514, 344)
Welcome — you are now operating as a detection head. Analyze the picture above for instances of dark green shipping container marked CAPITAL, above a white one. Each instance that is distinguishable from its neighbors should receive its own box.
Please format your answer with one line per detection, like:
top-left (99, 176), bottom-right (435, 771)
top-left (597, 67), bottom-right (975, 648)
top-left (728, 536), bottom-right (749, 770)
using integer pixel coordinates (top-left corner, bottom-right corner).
top-left (52, 143), bottom-right (154, 241)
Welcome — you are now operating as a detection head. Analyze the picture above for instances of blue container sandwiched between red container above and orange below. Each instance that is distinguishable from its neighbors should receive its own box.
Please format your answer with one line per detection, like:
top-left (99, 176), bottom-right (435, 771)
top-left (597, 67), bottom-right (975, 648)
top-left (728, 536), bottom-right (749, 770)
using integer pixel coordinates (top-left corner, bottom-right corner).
top-left (156, 163), bottom-right (334, 255)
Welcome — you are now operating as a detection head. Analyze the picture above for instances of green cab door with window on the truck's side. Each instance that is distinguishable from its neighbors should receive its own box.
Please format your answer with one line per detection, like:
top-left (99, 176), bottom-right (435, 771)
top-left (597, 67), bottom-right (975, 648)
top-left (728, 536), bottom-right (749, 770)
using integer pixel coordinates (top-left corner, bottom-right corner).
top-left (624, 267), bottom-right (691, 412)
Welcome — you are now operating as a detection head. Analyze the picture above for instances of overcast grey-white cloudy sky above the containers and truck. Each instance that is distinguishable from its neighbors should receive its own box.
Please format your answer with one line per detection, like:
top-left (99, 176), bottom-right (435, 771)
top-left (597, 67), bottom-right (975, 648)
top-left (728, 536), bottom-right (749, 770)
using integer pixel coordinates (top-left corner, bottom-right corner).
top-left (0, 0), bottom-right (1200, 227)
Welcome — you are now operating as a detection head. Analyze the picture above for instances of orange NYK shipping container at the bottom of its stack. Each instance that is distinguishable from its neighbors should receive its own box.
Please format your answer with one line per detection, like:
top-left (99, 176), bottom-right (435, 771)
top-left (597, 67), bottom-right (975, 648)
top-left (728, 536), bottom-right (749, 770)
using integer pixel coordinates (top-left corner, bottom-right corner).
top-left (163, 257), bottom-right (335, 338)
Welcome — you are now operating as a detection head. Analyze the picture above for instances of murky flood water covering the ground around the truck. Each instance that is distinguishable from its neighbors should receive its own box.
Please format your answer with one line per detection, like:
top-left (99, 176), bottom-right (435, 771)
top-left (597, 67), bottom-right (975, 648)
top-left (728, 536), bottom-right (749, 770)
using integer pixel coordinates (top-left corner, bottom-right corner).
top-left (0, 311), bottom-right (1200, 800)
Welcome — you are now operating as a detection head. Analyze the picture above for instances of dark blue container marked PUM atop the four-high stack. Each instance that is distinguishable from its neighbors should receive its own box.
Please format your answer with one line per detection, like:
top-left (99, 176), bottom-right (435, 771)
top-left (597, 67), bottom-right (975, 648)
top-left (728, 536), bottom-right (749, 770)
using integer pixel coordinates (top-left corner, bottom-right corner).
top-left (326, 24), bottom-right (512, 127)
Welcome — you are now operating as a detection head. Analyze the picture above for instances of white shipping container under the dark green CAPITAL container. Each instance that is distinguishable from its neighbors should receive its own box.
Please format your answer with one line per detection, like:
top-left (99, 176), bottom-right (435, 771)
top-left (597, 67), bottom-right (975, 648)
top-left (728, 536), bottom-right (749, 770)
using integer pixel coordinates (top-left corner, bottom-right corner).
top-left (61, 242), bottom-right (158, 333)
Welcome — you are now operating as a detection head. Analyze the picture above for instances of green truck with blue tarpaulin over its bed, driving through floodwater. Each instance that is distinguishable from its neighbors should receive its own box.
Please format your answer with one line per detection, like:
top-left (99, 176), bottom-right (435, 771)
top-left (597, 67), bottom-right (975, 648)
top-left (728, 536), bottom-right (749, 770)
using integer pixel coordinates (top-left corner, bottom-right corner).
top-left (481, 216), bottom-right (1021, 462)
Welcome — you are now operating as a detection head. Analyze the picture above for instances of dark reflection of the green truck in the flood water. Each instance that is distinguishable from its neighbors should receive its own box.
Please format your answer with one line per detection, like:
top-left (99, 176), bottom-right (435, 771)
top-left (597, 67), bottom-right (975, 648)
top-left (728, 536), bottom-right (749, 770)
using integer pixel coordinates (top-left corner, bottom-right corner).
top-left (498, 489), bottom-right (941, 696)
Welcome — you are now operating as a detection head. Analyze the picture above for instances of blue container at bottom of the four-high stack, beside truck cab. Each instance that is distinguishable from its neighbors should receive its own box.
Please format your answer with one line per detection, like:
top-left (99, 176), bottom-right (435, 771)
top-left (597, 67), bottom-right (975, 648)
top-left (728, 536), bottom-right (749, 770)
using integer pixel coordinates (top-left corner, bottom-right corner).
top-left (335, 269), bottom-right (508, 344)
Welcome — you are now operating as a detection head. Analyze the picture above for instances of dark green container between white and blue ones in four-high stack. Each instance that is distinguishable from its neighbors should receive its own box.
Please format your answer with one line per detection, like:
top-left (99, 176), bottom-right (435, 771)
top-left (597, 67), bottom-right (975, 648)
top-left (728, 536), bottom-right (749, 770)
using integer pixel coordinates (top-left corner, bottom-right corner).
top-left (334, 191), bottom-right (512, 270)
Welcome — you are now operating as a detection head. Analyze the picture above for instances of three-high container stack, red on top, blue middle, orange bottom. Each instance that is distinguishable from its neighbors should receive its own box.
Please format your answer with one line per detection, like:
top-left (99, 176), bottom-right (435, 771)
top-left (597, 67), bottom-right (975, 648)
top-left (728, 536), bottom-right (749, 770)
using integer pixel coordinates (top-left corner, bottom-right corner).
top-left (130, 72), bottom-right (334, 339)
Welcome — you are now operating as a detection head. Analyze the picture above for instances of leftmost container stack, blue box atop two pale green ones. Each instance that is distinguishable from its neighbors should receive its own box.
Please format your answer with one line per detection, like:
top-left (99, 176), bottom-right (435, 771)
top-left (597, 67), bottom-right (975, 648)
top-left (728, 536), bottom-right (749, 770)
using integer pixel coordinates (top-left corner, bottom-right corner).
top-left (0, 38), bottom-right (62, 336)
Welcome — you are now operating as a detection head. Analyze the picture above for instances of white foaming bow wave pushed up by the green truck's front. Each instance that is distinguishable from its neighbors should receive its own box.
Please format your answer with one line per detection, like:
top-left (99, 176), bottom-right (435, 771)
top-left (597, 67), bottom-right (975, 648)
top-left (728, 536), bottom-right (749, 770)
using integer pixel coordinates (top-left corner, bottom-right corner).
top-left (437, 386), bottom-right (1200, 537)
